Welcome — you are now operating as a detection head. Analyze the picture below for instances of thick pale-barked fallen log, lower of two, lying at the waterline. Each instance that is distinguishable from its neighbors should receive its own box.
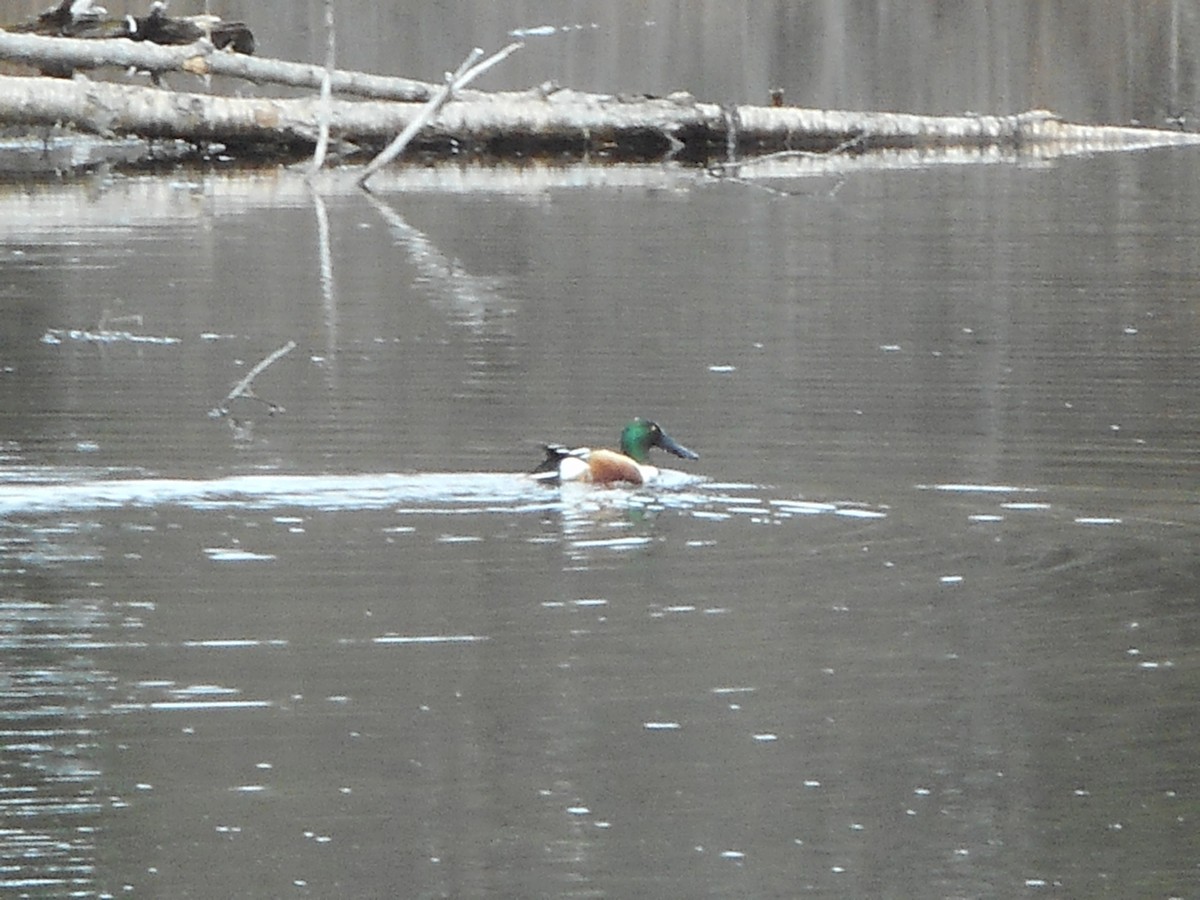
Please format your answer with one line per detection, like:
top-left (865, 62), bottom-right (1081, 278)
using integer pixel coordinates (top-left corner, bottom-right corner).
top-left (0, 71), bottom-right (1200, 162)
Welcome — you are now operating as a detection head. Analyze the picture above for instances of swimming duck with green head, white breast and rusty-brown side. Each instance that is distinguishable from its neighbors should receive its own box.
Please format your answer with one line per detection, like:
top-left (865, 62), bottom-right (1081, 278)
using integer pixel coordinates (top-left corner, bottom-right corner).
top-left (529, 418), bottom-right (700, 485)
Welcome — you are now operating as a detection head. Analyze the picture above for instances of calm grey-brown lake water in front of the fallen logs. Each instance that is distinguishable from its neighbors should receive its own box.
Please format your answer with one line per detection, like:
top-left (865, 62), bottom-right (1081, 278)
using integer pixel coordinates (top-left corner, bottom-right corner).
top-left (0, 4), bottom-right (1200, 898)
